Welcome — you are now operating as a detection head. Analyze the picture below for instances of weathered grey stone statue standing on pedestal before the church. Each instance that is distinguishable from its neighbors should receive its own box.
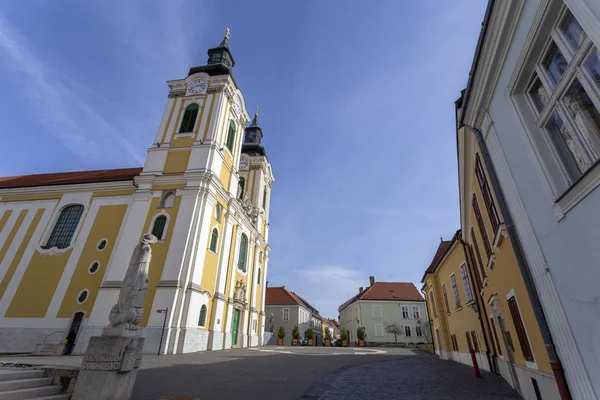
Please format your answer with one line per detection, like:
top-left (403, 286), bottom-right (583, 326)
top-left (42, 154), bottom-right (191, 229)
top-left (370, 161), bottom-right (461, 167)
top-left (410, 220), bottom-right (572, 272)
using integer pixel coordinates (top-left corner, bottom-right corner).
top-left (102, 233), bottom-right (157, 336)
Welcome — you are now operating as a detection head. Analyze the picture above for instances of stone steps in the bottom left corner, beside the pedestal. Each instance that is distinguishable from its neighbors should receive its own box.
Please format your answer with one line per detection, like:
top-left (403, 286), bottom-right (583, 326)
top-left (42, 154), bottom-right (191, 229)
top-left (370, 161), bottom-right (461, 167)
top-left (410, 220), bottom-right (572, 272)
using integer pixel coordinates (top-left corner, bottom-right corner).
top-left (0, 369), bottom-right (71, 400)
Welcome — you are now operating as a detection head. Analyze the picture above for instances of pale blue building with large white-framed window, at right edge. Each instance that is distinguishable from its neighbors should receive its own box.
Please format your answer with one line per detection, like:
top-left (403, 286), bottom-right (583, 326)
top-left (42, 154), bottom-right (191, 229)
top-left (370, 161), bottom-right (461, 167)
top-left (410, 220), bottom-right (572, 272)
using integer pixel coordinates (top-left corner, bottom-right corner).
top-left (459, 0), bottom-right (600, 400)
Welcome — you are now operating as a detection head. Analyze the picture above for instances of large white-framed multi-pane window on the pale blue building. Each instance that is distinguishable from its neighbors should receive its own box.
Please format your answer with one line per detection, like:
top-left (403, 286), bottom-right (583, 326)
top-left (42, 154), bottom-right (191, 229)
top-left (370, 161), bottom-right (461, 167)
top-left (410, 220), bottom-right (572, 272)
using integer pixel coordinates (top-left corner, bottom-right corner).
top-left (520, 6), bottom-right (600, 198)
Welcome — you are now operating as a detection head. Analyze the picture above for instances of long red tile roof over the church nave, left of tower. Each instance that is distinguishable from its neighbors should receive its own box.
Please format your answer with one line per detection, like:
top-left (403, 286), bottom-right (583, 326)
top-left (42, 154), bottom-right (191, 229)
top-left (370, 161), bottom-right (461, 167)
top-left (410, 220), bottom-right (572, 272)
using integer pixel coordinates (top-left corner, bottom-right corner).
top-left (0, 168), bottom-right (142, 189)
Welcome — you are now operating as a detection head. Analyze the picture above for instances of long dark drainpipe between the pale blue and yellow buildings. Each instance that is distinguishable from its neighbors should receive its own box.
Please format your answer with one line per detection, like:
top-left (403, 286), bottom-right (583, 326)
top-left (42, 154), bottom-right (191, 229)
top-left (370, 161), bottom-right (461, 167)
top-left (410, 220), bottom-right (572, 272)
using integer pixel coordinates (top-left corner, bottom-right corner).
top-left (459, 122), bottom-right (571, 400)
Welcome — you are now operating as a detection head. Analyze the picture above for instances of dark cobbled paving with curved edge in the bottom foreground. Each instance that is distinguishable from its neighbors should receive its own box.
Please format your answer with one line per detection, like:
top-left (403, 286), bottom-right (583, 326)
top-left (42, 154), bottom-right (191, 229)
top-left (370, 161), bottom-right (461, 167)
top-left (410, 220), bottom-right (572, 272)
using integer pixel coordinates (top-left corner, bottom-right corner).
top-left (300, 352), bottom-right (522, 400)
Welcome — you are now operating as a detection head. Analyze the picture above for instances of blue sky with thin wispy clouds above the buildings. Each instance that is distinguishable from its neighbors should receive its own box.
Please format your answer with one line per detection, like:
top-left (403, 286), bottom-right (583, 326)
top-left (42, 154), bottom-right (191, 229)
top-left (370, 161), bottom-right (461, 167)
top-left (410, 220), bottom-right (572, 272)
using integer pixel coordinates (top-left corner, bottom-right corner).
top-left (0, 0), bottom-right (485, 317)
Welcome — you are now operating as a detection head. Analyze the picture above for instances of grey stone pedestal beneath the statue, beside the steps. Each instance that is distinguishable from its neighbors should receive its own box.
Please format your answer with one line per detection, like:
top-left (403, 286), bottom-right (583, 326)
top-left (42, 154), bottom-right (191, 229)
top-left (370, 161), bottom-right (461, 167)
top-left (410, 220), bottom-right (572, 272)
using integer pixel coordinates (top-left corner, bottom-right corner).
top-left (71, 335), bottom-right (144, 400)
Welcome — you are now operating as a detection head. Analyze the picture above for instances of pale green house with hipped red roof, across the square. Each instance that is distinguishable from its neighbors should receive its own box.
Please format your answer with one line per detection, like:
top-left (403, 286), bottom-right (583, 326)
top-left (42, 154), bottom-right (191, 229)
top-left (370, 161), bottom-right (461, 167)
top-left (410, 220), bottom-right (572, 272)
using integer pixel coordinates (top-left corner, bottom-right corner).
top-left (338, 276), bottom-right (428, 343)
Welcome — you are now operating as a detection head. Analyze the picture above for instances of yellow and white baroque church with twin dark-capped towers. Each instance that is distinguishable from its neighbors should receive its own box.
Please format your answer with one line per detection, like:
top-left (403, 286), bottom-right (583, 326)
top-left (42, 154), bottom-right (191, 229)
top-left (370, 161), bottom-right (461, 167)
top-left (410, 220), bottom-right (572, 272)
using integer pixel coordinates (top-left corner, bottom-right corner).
top-left (0, 32), bottom-right (274, 354)
